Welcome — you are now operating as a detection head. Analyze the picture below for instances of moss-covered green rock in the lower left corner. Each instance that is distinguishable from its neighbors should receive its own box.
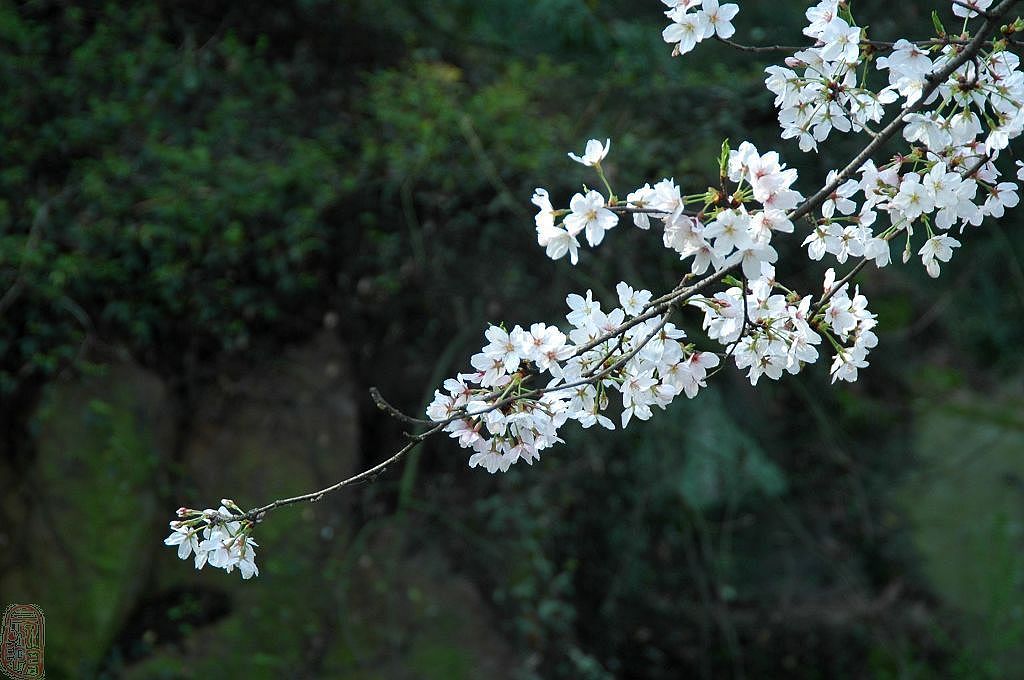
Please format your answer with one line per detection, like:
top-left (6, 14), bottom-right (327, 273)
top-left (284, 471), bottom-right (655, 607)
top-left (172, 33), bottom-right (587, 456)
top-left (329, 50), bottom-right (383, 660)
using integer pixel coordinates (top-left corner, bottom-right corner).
top-left (0, 364), bottom-right (171, 678)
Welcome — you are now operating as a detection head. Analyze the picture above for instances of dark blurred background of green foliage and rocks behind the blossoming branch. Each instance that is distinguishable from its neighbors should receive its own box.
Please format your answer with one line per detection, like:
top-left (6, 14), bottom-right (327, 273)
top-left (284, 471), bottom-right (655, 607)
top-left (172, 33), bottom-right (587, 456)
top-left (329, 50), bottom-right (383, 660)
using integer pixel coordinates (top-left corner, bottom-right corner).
top-left (0, 0), bottom-right (1024, 680)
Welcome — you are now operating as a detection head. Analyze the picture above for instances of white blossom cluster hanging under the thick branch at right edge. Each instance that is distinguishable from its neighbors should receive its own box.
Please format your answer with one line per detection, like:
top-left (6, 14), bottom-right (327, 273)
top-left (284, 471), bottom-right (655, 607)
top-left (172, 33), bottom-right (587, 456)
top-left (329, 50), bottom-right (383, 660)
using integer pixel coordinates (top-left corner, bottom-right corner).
top-left (804, 52), bottom-right (1024, 277)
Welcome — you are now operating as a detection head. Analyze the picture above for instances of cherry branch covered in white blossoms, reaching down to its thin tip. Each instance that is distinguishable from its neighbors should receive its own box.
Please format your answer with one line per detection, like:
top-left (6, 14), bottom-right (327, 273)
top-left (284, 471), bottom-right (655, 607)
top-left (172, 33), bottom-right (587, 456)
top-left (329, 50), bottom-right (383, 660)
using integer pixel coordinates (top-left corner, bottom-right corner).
top-left (165, 0), bottom-right (1024, 578)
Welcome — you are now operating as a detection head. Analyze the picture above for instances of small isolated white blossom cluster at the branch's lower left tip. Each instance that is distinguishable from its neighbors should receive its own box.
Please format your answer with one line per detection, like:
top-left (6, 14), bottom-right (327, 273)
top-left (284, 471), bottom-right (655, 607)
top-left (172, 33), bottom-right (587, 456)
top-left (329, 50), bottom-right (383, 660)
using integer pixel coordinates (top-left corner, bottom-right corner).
top-left (164, 499), bottom-right (259, 579)
